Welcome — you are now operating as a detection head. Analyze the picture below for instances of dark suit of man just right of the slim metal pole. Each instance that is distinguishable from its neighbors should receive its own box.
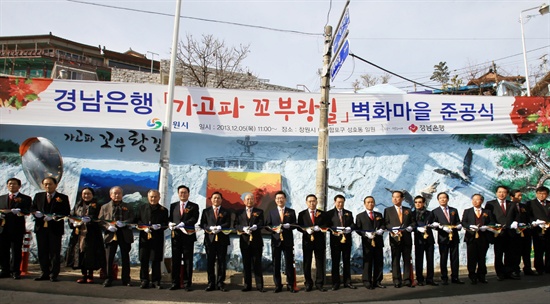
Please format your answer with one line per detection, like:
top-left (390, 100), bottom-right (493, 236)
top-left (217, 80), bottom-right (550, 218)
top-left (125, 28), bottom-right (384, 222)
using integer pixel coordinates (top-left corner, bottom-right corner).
top-left (170, 201), bottom-right (199, 288)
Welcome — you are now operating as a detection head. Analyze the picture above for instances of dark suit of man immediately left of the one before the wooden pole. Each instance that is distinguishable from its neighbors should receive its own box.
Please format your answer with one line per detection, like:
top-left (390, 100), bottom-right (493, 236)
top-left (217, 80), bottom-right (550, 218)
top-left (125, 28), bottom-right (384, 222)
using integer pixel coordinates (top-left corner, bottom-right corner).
top-left (265, 207), bottom-right (296, 288)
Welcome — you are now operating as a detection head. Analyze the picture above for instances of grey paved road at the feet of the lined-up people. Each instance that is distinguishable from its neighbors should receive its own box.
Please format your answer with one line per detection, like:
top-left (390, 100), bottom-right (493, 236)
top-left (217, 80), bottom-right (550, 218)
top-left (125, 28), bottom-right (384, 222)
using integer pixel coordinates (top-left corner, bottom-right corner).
top-left (0, 267), bottom-right (550, 304)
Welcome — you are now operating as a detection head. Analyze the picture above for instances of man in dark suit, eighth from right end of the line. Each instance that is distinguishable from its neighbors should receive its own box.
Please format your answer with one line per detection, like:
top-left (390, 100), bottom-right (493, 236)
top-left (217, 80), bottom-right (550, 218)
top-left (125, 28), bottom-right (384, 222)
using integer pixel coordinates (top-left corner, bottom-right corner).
top-left (355, 196), bottom-right (386, 289)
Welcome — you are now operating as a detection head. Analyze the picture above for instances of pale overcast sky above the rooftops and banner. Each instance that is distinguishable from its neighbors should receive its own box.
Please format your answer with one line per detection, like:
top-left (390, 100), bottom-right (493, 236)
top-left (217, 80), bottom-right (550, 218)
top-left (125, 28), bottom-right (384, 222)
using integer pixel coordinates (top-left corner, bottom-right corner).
top-left (0, 0), bottom-right (550, 92)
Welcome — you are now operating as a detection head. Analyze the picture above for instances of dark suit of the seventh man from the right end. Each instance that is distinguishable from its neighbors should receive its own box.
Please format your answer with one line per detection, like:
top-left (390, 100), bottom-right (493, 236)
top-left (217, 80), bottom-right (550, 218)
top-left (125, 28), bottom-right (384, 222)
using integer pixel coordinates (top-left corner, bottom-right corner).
top-left (384, 206), bottom-right (416, 285)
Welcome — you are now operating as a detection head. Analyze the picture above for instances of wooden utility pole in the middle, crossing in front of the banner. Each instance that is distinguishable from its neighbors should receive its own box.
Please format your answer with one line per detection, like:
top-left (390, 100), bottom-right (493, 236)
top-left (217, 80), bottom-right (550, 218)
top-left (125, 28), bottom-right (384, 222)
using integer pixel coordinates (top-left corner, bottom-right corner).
top-left (315, 25), bottom-right (332, 210)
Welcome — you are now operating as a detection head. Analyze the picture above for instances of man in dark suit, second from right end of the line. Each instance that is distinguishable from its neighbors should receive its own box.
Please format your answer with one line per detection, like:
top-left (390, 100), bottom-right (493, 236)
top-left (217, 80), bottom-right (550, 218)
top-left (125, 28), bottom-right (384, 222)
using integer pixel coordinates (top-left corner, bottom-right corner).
top-left (510, 189), bottom-right (536, 275)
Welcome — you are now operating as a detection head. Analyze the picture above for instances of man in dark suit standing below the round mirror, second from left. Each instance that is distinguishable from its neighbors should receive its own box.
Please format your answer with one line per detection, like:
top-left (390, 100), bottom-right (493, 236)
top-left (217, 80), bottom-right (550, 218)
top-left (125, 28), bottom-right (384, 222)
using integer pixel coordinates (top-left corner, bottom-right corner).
top-left (31, 177), bottom-right (71, 282)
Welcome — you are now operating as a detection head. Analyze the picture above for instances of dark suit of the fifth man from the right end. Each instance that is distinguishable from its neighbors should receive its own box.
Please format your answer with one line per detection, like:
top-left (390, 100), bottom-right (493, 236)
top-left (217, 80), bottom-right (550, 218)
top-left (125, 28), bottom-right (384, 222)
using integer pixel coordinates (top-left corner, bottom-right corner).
top-left (432, 207), bottom-right (460, 282)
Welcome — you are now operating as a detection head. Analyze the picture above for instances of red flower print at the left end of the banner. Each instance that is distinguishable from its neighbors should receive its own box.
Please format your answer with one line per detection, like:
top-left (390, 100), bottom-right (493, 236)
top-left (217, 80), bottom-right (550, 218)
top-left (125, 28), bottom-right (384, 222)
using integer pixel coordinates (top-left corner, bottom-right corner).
top-left (0, 77), bottom-right (52, 110)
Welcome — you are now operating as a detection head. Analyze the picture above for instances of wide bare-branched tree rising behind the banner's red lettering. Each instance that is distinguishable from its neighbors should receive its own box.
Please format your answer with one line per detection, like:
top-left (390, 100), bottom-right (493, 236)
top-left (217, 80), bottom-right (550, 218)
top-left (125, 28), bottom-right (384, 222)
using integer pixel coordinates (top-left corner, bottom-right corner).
top-left (177, 35), bottom-right (258, 89)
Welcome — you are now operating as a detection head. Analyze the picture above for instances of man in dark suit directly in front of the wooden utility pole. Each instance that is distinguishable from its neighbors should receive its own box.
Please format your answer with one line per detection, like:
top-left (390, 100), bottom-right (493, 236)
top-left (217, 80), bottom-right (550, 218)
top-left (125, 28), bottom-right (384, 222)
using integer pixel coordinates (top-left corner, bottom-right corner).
top-left (298, 194), bottom-right (327, 292)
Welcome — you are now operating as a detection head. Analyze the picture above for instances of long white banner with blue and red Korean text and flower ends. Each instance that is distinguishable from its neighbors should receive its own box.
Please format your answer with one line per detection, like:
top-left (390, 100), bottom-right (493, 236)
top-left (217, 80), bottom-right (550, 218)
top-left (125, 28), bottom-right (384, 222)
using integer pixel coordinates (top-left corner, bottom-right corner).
top-left (0, 77), bottom-right (550, 136)
